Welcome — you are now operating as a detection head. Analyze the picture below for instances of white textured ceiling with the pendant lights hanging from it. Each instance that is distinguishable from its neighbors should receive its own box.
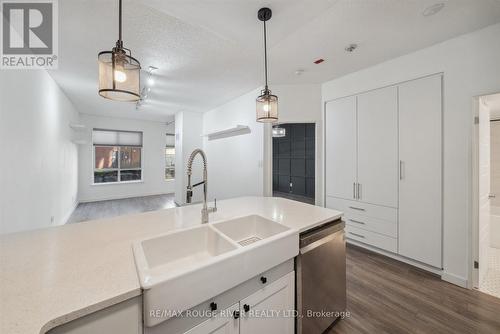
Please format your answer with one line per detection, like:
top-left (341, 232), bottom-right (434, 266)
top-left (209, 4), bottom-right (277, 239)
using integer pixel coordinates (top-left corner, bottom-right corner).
top-left (51, 0), bottom-right (500, 120)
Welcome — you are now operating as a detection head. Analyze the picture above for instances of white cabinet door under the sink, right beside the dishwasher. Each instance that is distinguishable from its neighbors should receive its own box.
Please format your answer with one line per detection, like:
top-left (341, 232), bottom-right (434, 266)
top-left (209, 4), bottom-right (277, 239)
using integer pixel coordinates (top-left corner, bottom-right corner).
top-left (240, 272), bottom-right (295, 334)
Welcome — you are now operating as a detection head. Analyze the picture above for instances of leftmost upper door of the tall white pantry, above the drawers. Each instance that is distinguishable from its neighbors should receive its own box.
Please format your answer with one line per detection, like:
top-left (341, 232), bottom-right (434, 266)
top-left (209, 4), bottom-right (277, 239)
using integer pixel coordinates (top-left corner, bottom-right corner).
top-left (325, 97), bottom-right (356, 199)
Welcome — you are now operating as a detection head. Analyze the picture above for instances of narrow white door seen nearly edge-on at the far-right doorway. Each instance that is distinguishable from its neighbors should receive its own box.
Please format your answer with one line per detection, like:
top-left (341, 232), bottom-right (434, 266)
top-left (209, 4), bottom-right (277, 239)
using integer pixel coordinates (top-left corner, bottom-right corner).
top-left (477, 98), bottom-right (491, 287)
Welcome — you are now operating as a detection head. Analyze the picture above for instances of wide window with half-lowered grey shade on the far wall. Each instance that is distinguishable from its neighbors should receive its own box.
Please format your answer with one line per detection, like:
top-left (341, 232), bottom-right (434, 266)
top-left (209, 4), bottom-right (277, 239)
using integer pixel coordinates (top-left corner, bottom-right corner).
top-left (92, 129), bottom-right (142, 184)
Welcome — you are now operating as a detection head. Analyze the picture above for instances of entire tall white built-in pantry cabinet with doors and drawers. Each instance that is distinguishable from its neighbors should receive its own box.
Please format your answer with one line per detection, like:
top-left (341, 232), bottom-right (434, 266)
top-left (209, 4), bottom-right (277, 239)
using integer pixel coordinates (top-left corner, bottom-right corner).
top-left (325, 75), bottom-right (442, 268)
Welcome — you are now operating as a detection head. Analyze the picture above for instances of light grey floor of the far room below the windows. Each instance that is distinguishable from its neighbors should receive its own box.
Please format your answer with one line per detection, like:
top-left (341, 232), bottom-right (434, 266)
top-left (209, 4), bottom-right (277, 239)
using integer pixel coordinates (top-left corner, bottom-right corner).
top-left (68, 194), bottom-right (176, 224)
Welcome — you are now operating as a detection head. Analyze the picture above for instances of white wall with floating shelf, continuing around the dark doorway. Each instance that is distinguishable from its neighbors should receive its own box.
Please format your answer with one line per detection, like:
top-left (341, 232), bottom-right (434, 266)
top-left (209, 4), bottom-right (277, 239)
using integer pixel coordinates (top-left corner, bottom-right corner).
top-left (203, 85), bottom-right (323, 199)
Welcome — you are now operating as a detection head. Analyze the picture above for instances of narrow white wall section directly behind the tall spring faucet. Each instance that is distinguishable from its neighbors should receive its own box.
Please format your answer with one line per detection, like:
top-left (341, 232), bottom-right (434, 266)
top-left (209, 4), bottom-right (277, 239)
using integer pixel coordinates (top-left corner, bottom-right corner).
top-left (175, 111), bottom-right (202, 205)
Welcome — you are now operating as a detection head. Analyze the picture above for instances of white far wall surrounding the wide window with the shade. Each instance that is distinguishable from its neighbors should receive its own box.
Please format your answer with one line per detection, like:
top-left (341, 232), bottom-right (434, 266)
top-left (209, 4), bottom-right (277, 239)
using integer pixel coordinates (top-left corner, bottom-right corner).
top-left (78, 114), bottom-right (175, 202)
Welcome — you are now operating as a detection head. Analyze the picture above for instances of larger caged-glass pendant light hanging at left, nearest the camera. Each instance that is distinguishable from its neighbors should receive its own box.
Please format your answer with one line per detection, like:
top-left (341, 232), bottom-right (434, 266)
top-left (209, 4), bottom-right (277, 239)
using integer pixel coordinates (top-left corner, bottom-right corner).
top-left (97, 0), bottom-right (141, 102)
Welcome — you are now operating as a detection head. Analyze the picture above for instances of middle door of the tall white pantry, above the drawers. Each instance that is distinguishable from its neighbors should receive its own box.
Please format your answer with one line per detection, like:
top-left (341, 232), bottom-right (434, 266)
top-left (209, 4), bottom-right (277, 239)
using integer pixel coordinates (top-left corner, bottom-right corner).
top-left (358, 87), bottom-right (398, 208)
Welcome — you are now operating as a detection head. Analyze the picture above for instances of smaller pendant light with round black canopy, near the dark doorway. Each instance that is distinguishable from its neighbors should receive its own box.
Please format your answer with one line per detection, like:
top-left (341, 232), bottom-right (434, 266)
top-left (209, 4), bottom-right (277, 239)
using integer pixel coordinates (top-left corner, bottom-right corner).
top-left (256, 8), bottom-right (278, 123)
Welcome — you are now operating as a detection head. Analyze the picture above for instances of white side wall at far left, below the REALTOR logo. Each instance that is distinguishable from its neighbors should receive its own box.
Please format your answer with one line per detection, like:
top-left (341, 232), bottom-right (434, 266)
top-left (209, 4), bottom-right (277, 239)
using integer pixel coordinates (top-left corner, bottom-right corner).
top-left (0, 70), bottom-right (78, 233)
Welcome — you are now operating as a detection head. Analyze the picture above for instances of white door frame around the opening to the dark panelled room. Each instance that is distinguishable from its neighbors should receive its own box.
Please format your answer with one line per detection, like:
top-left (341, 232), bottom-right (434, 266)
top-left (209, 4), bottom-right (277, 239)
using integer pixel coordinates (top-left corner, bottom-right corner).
top-left (263, 120), bottom-right (322, 206)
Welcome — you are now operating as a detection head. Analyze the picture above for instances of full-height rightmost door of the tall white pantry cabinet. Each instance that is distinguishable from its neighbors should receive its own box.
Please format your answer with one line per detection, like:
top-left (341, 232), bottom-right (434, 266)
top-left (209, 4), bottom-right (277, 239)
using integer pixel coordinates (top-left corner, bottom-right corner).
top-left (399, 75), bottom-right (442, 268)
